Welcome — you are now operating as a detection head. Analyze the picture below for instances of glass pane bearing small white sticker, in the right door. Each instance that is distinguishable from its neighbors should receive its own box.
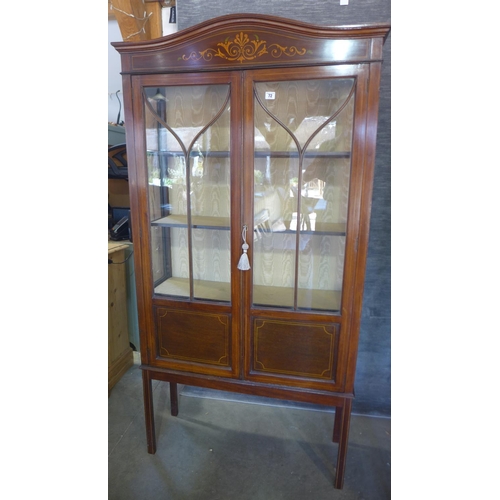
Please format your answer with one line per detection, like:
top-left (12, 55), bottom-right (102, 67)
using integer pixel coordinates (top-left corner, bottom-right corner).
top-left (253, 78), bottom-right (354, 311)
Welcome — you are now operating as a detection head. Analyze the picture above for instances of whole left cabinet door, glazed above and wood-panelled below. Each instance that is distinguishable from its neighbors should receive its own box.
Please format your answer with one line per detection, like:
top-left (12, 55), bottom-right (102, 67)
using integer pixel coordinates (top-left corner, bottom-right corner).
top-left (134, 74), bottom-right (241, 376)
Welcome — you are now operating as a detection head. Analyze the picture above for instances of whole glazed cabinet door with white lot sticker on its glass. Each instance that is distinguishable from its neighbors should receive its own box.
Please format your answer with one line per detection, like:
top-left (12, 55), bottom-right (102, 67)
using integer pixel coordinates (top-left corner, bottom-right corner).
top-left (244, 66), bottom-right (366, 390)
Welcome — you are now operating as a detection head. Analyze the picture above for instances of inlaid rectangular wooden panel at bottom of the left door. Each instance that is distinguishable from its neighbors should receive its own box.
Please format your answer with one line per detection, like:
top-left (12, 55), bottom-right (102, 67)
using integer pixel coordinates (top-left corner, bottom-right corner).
top-left (156, 307), bottom-right (231, 367)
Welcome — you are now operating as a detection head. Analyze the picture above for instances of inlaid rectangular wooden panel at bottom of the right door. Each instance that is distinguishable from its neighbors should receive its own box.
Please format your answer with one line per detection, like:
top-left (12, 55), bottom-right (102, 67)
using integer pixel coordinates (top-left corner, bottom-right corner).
top-left (253, 318), bottom-right (339, 380)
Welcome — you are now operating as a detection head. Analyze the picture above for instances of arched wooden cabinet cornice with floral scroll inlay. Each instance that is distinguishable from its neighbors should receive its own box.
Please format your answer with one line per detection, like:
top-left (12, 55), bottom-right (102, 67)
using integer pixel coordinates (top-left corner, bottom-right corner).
top-left (112, 14), bottom-right (390, 74)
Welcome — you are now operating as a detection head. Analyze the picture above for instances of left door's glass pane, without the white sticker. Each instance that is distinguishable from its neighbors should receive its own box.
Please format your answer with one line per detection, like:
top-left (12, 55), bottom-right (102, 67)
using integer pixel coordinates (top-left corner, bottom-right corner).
top-left (144, 85), bottom-right (231, 301)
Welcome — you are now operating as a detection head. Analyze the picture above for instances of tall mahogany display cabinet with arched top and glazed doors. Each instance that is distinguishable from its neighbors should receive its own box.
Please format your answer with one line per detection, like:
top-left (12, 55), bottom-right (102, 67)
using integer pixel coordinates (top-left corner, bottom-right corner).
top-left (113, 14), bottom-right (389, 488)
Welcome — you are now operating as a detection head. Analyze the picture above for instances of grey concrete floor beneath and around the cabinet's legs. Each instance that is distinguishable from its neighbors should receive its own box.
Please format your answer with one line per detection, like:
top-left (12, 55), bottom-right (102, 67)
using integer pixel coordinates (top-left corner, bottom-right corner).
top-left (108, 354), bottom-right (391, 500)
